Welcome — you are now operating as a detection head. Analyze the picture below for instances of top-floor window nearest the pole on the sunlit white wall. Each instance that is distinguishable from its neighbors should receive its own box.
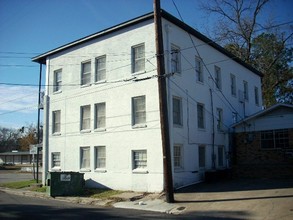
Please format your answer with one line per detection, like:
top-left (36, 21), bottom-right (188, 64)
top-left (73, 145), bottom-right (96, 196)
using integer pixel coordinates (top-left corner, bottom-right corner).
top-left (132, 44), bottom-right (145, 73)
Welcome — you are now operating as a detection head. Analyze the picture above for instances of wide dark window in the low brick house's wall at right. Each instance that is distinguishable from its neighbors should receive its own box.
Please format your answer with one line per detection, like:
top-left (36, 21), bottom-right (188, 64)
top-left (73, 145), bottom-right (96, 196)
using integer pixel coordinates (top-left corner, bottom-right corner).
top-left (261, 129), bottom-right (289, 149)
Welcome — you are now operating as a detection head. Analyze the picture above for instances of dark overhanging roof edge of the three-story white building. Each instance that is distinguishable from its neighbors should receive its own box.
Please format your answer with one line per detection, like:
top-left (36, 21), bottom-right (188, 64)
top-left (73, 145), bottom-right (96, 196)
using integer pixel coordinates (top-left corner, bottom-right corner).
top-left (32, 10), bottom-right (263, 77)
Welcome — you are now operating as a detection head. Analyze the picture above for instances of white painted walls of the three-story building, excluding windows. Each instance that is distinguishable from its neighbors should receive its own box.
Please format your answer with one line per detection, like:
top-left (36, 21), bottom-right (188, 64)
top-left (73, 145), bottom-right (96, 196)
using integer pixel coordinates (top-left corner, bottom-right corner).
top-left (43, 15), bottom-right (261, 192)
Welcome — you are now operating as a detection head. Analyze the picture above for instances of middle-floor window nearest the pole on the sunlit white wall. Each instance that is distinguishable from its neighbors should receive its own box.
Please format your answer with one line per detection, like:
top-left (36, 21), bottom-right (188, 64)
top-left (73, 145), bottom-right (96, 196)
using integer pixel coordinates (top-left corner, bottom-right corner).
top-left (132, 96), bottom-right (146, 125)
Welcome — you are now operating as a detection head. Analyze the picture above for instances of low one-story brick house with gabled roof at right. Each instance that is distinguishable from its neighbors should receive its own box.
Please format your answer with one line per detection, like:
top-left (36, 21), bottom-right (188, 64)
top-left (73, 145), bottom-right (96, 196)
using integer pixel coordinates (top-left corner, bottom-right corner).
top-left (233, 104), bottom-right (293, 178)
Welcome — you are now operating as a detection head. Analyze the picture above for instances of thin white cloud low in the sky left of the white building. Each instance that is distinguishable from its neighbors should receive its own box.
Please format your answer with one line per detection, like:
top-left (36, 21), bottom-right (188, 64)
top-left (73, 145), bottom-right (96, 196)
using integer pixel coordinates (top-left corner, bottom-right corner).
top-left (0, 85), bottom-right (38, 114)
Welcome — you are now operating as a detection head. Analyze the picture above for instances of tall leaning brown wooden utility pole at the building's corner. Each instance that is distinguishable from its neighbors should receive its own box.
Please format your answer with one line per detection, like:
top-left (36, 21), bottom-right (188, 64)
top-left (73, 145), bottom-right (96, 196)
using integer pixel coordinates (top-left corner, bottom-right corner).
top-left (154, 0), bottom-right (174, 203)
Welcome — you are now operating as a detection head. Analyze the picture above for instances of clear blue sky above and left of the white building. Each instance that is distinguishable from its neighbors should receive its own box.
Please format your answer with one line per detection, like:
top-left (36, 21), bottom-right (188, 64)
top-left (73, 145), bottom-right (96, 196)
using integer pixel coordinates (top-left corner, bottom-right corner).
top-left (0, 0), bottom-right (293, 128)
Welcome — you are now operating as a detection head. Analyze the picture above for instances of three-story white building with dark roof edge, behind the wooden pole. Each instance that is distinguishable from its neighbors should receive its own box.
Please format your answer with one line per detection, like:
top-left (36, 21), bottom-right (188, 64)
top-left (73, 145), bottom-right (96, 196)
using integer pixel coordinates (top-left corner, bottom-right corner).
top-left (33, 11), bottom-right (262, 192)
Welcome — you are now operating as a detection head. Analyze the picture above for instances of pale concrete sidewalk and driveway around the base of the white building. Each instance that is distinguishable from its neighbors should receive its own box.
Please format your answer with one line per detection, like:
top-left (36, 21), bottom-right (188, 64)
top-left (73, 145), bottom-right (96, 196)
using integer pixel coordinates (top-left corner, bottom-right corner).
top-left (0, 179), bottom-right (293, 220)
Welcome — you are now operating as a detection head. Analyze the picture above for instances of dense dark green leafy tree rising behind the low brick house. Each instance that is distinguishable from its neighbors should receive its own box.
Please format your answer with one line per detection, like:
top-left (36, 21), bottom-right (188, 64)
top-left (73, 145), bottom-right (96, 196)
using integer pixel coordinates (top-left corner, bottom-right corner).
top-left (251, 33), bottom-right (293, 106)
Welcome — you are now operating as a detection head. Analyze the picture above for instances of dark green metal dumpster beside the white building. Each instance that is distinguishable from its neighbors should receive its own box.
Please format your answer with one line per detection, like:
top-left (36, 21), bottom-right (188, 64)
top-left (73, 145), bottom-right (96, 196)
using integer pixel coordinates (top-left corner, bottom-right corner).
top-left (46, 172), bottom-right (84, 197)
